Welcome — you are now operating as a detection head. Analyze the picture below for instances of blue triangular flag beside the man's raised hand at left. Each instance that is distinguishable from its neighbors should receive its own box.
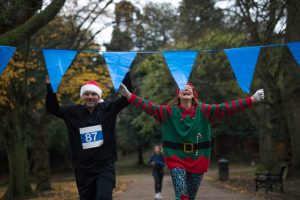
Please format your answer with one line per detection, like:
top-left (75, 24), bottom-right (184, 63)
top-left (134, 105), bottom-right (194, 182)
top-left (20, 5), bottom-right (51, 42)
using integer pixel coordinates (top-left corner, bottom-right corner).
top-left (43, 49), bottom-right (77, 93)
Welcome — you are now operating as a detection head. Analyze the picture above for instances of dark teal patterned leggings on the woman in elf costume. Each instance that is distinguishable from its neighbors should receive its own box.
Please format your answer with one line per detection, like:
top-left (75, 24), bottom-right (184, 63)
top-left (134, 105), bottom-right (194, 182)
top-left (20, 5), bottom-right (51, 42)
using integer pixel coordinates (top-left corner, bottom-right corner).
top-left (171, 167), bottom-right (203, 200)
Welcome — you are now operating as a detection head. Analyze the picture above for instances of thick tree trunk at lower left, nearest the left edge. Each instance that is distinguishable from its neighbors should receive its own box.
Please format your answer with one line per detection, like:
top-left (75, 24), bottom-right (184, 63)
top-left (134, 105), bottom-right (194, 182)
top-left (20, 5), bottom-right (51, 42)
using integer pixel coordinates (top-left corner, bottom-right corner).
top-left (3, 111), bottom-right (32, 200)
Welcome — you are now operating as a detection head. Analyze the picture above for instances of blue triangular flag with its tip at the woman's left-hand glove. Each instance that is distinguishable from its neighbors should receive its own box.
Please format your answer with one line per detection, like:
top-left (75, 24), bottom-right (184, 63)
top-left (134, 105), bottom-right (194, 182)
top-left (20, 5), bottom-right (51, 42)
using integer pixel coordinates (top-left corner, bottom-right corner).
top-left (103, 52), bottom-right (136, 92)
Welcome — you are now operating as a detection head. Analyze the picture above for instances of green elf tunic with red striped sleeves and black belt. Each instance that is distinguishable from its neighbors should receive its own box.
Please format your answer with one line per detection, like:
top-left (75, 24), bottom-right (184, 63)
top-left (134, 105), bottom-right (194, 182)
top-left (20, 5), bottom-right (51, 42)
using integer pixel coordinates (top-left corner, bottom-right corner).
top-left (128, 94), bottom-right (253, 173)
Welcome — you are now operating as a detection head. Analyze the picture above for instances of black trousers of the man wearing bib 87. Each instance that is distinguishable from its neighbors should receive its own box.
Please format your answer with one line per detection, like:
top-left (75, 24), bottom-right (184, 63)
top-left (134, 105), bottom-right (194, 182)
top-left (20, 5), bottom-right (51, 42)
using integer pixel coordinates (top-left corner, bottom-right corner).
top-left (74, 161), bottom-right (116, 200)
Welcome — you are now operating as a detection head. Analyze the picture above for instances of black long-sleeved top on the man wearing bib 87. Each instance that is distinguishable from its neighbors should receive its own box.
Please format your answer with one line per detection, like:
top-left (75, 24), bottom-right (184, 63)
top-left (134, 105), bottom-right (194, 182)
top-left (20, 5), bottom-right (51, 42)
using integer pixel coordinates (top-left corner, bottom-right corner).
top-left (45, 73), bottom-right (132, 169)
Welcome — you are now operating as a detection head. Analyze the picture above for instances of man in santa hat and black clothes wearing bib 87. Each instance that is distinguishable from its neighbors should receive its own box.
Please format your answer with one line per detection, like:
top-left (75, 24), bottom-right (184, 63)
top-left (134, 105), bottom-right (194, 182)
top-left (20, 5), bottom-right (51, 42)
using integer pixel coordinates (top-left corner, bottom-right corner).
top-left (45, 73), bottom-right (132, 200)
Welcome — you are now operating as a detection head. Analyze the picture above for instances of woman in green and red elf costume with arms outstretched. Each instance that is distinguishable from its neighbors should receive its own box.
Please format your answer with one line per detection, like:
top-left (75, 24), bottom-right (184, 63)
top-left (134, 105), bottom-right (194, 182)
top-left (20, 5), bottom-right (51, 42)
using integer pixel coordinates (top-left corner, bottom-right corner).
top-left (119, 83), bottom-right (264, 200)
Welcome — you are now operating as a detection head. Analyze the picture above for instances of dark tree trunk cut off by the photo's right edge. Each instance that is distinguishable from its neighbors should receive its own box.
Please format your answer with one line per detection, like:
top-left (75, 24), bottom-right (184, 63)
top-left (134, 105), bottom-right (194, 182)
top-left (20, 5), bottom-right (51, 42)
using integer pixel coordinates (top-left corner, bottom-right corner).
top-left (282, 0), bottom-right (300, 176)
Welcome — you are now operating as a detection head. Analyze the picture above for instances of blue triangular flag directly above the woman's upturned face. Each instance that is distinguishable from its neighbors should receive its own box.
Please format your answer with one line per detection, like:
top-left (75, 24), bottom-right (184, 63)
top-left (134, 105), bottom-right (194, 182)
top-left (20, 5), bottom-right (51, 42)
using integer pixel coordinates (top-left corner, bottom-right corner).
top-left (163, 51), bottom-right (198, 90)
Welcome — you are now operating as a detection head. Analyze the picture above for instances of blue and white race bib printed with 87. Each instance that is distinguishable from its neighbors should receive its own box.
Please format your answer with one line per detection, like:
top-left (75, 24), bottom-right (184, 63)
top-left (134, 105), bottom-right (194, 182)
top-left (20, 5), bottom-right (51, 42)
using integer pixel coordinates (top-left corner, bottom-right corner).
top-left (79, 124), bottom-right (103, 149)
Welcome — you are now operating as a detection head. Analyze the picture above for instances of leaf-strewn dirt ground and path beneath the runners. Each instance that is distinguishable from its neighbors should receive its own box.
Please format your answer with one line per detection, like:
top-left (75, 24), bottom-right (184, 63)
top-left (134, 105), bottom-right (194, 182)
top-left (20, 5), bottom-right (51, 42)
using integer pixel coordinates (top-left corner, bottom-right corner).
top-left (0, 169), bottom-right (300, 200)
